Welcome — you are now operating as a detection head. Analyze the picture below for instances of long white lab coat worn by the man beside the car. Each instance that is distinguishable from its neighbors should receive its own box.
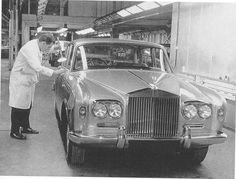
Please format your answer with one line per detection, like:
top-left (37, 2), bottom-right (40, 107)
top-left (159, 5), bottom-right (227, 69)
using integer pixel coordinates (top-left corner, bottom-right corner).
top-left (9, 39), bottom-right (53, 109)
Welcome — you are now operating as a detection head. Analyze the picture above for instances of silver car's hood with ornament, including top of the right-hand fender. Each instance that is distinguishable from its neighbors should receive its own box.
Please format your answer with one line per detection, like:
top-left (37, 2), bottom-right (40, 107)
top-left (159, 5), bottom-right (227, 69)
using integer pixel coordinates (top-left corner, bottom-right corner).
top-left (78, 69), bottom-right (214, 102)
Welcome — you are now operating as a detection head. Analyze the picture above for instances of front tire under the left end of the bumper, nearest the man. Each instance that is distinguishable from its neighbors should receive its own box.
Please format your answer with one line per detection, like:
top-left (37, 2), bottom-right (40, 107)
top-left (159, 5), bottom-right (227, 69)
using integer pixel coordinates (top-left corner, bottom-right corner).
top-left (66, 125), bottom-right (85, 165)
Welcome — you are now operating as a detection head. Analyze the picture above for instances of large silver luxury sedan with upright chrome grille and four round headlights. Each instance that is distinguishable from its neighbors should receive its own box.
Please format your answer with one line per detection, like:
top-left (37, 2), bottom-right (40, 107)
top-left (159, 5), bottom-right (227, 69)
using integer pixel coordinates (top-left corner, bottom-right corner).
top-left (53, 38), bottom-right (227, 165)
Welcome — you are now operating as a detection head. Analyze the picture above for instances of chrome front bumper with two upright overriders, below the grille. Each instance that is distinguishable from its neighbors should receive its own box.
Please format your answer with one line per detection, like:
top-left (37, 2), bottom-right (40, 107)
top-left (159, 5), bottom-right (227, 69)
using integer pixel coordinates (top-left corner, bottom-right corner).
top-left (69, 126), bottom-right (227, 149)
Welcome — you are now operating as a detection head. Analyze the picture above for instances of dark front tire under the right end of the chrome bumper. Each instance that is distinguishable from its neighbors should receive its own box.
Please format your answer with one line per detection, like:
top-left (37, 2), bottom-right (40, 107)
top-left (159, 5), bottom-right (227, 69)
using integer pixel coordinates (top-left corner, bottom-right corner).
top-left (181, 146), bottom-right (208, 164)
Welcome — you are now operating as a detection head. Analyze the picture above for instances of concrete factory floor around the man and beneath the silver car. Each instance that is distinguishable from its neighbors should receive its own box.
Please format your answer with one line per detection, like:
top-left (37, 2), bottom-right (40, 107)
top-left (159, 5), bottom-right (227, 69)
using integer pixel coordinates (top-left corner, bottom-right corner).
top-left (0, 60), bottom-right (235, 179)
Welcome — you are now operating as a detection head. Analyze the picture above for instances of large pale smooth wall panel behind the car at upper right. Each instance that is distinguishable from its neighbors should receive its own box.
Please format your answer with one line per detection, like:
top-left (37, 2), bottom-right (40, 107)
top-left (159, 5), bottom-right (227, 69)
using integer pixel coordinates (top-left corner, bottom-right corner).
top-left (171, 3), bottom-right (236, 82)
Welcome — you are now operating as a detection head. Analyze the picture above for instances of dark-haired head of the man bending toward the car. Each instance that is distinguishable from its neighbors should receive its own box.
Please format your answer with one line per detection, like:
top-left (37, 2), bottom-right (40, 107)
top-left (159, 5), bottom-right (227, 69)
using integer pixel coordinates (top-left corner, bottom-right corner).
top-left (38, 34), bottom-right (55, 54)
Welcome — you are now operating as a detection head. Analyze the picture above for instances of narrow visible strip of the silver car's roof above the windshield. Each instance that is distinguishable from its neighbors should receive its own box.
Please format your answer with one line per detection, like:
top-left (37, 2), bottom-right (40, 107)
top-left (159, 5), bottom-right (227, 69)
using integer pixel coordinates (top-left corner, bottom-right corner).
top-left (72, 38), bottom-right (164, 48)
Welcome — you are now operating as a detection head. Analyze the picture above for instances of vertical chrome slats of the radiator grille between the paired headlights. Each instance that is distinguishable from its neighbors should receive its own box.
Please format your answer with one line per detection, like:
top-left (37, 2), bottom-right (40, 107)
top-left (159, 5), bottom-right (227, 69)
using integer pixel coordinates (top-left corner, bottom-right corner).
top-left (126, 96), bottom-right (179, 138)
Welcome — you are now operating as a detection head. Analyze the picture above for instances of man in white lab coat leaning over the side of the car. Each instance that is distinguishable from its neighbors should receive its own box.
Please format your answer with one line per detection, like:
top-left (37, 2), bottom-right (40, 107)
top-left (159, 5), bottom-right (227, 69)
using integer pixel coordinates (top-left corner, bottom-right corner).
top-left (9, 34), bottom-right (65, 139)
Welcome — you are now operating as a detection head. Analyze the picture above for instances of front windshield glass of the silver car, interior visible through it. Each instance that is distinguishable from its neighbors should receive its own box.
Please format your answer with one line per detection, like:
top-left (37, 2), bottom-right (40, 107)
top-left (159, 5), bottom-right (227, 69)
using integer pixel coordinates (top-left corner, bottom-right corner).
top-left (83, 44), bottom-right (171, 72)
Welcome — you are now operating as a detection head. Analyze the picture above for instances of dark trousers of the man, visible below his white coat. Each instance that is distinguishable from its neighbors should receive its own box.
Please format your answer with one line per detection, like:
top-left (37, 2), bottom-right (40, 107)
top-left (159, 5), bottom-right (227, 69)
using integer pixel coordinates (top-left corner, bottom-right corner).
top-left (11, 106), bottom-right (31, 133)
